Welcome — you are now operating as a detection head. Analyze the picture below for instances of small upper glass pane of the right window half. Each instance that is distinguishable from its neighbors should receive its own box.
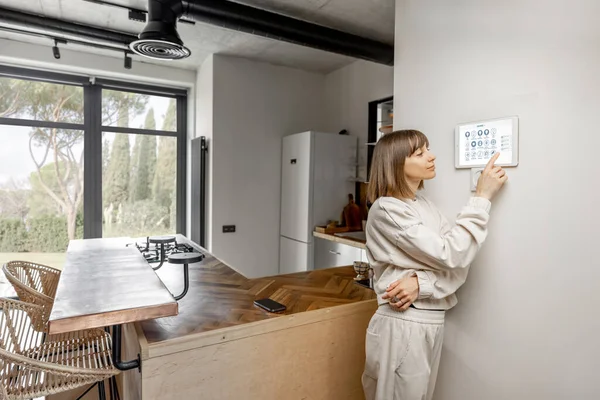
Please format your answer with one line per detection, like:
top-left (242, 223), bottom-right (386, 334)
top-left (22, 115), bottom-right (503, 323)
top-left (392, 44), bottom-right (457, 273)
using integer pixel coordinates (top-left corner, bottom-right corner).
top-left (102, 90), bottom-right (177, 132)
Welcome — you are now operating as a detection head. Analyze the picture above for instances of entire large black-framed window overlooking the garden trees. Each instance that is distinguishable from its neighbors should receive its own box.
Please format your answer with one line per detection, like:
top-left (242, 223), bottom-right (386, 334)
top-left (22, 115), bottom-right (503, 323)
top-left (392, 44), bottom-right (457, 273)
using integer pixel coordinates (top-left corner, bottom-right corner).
top-left (0, 66), bottom-right (186, 268)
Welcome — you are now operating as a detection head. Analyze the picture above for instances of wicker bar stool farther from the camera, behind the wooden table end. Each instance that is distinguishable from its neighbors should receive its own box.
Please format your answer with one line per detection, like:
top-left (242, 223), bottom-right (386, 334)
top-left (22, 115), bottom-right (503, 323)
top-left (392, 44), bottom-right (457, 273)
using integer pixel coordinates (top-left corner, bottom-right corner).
top-left (2, 261), bottom-right (60, 330)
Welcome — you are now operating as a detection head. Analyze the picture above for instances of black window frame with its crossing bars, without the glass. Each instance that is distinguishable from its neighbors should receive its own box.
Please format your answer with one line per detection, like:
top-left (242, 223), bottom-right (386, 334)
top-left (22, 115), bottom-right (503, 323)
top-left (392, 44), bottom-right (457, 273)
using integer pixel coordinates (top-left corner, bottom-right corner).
top-left (0, 64), bottom-right (188, 239)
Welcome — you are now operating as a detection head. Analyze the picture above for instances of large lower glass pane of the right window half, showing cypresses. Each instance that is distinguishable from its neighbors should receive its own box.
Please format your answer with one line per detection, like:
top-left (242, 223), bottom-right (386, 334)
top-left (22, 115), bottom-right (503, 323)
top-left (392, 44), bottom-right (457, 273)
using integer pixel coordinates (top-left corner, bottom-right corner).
top-left (102, 132), bottom-right (177, 237)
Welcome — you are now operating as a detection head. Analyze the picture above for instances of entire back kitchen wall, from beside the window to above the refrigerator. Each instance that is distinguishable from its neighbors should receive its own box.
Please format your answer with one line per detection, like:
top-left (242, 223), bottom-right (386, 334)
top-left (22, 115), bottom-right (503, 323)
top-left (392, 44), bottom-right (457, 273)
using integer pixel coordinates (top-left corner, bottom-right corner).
top-left (202, 55), bottom-right (394, 277)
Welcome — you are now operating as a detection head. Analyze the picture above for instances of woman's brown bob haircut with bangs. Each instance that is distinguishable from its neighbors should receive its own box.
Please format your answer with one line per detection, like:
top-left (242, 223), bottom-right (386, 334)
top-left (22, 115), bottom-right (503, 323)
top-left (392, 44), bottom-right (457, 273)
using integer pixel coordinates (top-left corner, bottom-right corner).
top-left (367, 129), bottom-right (429, 203)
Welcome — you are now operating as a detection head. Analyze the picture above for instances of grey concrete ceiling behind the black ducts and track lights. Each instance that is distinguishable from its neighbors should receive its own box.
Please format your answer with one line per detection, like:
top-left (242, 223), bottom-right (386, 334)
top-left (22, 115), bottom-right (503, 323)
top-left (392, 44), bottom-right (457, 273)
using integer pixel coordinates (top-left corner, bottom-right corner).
top-left (0, 0), bottom-right (394, 73)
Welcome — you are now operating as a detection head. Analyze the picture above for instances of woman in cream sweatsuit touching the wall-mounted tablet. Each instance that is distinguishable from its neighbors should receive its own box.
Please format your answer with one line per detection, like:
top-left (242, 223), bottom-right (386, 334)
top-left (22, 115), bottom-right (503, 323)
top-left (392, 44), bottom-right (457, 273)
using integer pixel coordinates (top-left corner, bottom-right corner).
top-left (362, 130), bottom-right (508, 400)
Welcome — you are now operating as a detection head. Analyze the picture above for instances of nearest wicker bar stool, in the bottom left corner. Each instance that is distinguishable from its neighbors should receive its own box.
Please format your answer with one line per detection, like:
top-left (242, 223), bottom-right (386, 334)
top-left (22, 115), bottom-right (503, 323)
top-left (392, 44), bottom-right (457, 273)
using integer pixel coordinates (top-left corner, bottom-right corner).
top-left (0, 298), bottom-right (119, 400)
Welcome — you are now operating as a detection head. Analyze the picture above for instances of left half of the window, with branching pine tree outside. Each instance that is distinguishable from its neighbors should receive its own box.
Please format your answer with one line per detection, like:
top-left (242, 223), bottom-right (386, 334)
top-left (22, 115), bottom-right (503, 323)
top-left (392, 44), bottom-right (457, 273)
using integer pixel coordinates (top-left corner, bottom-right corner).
top-left (0, 77), bottom-right (84, 266)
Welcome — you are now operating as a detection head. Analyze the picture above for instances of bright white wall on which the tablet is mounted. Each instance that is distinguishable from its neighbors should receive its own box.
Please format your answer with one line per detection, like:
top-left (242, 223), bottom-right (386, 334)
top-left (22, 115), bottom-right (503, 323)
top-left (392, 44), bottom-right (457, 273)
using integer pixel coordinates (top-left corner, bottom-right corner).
top-left (394, 0), bottom-right (600, 400)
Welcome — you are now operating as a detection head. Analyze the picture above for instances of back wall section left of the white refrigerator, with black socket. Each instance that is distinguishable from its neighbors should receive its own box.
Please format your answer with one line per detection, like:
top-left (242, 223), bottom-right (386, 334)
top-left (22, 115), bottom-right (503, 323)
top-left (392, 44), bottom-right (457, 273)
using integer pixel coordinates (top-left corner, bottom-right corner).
top-left (210, 55), bottom-right (325, 277)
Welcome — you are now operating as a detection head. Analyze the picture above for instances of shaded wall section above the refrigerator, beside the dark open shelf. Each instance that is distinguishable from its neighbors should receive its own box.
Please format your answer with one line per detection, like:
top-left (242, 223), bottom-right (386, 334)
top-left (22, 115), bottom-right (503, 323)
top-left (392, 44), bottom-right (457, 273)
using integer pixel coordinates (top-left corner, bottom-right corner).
top-left (325, 60), bottom-right (394, 180)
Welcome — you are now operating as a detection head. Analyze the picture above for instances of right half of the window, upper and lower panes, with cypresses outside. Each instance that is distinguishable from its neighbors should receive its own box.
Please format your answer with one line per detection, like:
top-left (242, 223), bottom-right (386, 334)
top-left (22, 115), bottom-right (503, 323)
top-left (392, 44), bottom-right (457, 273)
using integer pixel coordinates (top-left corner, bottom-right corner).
top-left (102, 90), bottom-right (177, 237)
